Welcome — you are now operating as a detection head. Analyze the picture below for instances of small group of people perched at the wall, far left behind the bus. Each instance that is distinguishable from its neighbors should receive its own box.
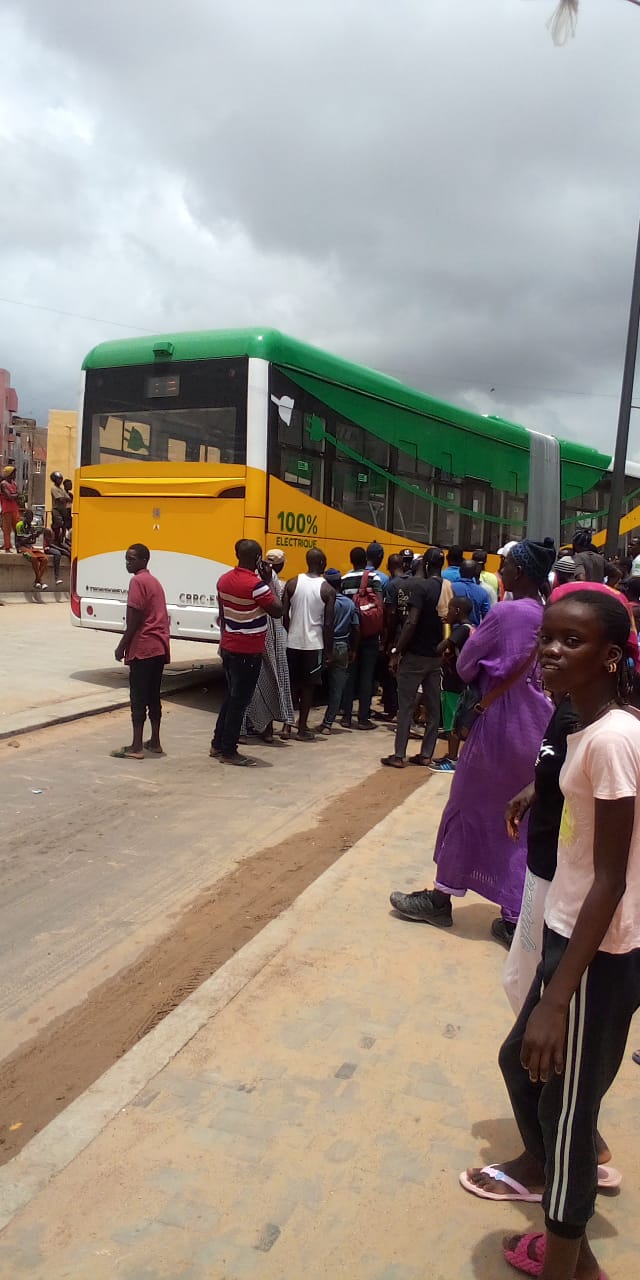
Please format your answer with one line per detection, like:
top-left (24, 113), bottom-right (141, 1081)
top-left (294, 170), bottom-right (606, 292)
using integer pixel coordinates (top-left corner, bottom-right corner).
top-left (0, 463), bottom-right (73, 591)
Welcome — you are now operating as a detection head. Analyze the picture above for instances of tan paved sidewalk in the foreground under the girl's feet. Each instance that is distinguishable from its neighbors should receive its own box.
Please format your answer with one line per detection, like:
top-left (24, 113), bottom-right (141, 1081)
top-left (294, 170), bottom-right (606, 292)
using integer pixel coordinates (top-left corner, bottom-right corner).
top-left (0, 773), bottom-right (640, 1280)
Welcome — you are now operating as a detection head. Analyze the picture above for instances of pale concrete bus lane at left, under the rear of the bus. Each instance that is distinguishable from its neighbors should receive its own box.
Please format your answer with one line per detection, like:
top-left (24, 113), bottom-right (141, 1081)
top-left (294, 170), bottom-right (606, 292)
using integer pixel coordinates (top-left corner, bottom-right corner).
top-left (0, 599), bottom-right (219, 736)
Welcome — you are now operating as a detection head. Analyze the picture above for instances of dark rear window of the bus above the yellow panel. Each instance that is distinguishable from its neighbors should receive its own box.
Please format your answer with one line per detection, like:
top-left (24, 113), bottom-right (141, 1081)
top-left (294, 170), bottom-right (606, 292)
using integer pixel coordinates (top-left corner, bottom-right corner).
top-left (82, 360), bottom-right (247, 466)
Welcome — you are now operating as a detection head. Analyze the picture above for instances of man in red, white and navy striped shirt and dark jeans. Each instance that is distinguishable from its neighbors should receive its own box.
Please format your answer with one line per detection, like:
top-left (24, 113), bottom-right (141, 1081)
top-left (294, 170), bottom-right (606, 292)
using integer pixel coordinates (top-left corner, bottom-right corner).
top-left (209, 538), bottom-right (282, 765)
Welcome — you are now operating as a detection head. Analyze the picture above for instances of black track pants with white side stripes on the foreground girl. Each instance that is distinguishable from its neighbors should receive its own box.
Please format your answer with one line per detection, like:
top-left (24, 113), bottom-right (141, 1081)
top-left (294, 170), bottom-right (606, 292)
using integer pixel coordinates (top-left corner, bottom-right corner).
top-left (499, 929), bottom-right (640, 1239)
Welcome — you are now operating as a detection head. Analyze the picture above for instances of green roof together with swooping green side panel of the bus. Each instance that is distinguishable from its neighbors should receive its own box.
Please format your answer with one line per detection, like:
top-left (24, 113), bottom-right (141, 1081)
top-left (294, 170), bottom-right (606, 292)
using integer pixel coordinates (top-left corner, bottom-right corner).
top-left (82, 329), bottom-right (611, 499)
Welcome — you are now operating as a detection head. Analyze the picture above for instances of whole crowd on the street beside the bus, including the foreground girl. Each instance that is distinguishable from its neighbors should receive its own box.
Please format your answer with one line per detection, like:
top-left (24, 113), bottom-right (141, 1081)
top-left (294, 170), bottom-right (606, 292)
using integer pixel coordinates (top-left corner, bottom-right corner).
top-left (113, 530), bottom-right (640, 1280)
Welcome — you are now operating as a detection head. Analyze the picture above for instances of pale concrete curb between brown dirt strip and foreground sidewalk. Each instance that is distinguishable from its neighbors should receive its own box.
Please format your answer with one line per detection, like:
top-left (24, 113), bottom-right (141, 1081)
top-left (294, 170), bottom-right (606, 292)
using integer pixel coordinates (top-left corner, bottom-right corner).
top-left (0, 774), bottom-right (449, 1231)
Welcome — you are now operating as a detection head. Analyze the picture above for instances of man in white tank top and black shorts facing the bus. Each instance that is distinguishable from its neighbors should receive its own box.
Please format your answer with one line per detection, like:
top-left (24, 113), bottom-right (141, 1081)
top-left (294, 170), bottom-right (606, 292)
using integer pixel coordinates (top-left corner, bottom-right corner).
top-left (283, 547), bottom-right (335, 742)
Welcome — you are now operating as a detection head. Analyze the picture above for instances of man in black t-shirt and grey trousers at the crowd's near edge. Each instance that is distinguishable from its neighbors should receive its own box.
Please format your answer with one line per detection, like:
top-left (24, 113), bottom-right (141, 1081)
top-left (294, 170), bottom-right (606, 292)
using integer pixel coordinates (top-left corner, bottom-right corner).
top-left (381, 547), bottom-right (444, 769)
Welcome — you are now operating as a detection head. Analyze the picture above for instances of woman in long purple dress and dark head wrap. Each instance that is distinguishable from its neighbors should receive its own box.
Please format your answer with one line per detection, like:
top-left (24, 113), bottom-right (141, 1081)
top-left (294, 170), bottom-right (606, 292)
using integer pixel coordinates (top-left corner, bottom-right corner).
top-left (390, 540), bottom-right (554, 946)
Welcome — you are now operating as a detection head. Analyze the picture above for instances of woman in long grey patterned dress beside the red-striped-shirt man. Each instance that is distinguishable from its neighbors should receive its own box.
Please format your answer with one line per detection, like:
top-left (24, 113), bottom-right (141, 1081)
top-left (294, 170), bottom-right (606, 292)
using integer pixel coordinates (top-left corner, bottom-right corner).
top-left (242, 547), bottom-right (296, 742)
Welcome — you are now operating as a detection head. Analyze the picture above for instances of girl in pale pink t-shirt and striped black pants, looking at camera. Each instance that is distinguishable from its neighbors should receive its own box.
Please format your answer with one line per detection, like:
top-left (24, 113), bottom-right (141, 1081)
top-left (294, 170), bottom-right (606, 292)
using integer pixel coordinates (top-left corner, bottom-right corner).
top-left (486, 585), bottom-right (640, 1280)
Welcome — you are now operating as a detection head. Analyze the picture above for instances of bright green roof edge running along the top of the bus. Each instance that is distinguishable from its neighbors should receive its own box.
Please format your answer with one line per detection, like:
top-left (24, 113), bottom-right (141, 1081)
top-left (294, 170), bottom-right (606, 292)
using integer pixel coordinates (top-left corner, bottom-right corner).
top-left (82, 328), bottom-right (611, 489)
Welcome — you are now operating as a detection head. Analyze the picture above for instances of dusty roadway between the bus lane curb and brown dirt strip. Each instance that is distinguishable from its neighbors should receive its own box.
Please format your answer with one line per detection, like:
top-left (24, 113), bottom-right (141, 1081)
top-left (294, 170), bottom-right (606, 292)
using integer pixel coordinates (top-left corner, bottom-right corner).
top-left (0, 687), bottom-right (389, 1053)
